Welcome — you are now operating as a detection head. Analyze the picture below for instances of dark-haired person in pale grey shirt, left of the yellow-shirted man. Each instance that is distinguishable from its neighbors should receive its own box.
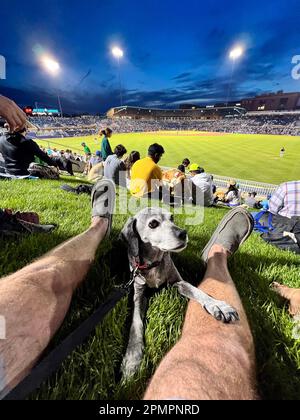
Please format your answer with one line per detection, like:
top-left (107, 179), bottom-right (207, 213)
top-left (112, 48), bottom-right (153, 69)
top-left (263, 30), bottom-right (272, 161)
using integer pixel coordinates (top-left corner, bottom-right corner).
top-left (104, 144), bottom-right (127, 188)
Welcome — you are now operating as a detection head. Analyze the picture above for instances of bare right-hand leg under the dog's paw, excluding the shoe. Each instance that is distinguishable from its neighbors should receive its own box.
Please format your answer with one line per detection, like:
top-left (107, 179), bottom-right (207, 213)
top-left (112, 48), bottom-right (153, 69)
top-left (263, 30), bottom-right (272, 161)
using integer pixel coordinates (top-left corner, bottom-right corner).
top-left (145, 245), bottom-right (256, 400)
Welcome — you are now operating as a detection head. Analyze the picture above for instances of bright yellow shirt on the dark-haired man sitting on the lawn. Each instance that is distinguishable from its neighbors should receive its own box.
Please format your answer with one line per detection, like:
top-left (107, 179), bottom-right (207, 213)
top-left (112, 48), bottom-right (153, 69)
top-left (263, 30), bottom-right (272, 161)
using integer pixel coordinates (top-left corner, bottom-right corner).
top-left (130, 157), bottom-right (162, 197)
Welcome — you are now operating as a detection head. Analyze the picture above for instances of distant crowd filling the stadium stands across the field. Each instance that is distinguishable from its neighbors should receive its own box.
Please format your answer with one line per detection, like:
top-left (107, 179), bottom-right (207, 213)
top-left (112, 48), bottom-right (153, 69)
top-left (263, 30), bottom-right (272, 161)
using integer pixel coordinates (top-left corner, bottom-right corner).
top-left (24, 113), bottom-right (300, 137)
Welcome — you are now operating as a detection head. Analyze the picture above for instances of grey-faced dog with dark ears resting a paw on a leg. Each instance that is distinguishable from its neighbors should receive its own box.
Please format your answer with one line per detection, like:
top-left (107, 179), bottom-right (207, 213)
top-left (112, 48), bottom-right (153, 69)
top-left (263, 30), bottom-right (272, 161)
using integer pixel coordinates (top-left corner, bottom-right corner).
top-left (121, 208), bottom-right (239, 379)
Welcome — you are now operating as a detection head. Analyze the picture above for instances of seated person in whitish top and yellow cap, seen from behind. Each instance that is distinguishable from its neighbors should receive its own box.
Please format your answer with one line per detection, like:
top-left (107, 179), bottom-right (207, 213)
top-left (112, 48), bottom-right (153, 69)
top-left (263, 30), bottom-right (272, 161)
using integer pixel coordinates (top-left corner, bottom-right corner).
top-left (190, 163), bottom-right (214, 207)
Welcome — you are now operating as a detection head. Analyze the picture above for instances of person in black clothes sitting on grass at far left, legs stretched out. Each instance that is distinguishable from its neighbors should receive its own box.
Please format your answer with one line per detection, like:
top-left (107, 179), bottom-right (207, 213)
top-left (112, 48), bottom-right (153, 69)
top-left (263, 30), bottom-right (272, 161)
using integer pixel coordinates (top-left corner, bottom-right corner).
top-left (0, 127), bottom-right (73, 176)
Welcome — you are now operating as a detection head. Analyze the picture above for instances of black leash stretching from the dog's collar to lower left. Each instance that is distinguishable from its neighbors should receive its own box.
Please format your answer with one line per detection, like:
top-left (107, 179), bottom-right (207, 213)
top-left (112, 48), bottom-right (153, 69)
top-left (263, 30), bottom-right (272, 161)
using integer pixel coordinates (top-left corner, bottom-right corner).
top-left (3, 286), bottom-right (134, 400)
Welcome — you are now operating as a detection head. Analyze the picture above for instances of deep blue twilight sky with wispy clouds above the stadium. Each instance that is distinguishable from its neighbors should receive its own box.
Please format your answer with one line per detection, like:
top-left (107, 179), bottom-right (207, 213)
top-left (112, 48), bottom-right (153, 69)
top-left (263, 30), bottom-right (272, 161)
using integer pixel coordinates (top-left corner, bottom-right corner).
top-left (0, 0), bottom-right (300, 112)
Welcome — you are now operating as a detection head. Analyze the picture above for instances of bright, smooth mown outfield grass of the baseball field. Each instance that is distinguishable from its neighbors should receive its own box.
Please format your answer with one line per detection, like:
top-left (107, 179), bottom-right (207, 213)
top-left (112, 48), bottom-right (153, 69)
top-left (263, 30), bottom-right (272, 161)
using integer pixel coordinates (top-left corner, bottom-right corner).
top-left (41, 132), bottom-right (300, 184)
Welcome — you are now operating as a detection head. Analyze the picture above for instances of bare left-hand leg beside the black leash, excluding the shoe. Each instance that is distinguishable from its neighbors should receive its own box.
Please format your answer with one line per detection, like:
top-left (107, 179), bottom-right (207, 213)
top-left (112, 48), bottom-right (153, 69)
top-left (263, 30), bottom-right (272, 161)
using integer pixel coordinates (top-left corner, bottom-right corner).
top-left (0, 217), bottom-right (108, 395)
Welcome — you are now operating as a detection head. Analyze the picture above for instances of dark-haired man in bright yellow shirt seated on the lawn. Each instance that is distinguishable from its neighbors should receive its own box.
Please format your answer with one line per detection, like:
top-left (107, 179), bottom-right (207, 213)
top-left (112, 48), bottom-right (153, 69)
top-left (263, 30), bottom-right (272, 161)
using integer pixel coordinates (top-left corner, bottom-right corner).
top-left (130, 143), bottom-right (165, 198)
